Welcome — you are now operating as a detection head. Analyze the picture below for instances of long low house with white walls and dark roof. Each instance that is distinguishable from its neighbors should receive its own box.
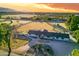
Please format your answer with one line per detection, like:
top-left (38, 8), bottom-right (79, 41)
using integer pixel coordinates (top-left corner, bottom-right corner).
top-left (28, 30), bottom-right (71, 41)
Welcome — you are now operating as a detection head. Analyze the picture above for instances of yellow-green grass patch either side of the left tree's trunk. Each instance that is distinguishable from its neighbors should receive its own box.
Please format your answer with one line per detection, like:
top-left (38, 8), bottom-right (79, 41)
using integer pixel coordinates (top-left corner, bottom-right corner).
top-left (0, 39), bottom-right (28, 51)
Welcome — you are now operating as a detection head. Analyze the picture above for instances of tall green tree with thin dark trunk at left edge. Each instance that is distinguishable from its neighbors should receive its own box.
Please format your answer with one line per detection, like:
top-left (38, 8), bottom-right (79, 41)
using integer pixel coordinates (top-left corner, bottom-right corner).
top-left (0, 20), bottom-right (12, 56)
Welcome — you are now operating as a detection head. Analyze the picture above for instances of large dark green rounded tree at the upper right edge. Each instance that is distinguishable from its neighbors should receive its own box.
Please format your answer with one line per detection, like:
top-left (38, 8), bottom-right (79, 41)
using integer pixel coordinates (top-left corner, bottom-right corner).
top-left (66, 15), bottom-right (79, 31)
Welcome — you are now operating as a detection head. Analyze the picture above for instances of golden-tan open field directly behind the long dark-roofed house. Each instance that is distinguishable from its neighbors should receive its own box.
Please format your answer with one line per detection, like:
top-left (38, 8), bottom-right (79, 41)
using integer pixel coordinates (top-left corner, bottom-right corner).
top-left (17, 22), bottom-right (55, 32)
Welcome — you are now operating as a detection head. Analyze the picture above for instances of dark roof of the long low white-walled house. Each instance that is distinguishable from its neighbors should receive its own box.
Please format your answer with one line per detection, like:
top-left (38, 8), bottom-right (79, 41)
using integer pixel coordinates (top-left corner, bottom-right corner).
top-left (28, 30), bottom-right (69, 38)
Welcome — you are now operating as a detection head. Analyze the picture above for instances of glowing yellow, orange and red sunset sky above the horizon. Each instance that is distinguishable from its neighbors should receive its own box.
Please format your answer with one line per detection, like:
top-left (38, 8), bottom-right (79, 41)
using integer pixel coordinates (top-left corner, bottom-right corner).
top-left (0, 3), bottom-right (79, 12)
